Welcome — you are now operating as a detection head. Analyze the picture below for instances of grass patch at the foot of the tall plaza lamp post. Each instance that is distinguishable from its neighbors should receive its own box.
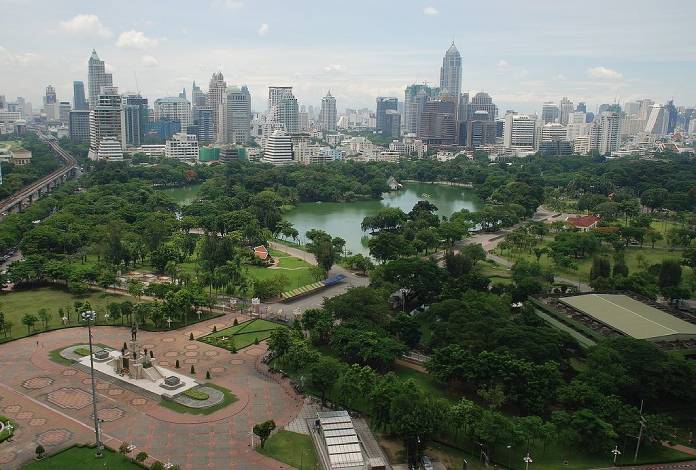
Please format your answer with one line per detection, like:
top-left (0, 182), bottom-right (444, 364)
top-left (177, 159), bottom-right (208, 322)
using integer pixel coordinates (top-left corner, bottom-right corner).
top-left (22, 446), bottom-right (143, 470)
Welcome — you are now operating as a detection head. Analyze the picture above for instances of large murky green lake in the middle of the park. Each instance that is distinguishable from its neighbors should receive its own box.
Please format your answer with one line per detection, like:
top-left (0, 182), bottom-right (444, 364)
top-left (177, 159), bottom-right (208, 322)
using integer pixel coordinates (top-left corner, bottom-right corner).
top-left (284, 183), bottom-right (481, 255)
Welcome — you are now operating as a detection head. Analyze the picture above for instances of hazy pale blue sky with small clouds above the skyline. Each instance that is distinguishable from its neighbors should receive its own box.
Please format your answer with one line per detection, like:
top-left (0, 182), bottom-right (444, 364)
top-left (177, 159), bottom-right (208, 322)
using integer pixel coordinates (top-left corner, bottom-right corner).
top-left (0, 0), bottom-right (696, 112)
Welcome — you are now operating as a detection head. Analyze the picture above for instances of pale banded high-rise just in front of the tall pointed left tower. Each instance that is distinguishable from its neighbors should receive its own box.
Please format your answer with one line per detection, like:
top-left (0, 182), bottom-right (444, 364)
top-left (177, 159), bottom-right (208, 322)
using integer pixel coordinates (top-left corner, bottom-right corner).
top-left (89, 86), bottom-right (126, 160)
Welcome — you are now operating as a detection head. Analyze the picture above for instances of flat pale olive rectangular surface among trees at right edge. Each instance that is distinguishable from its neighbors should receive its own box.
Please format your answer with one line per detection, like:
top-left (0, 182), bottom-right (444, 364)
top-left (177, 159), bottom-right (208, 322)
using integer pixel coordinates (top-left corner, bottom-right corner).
top-left (559, 294), bottom-right (696, 341)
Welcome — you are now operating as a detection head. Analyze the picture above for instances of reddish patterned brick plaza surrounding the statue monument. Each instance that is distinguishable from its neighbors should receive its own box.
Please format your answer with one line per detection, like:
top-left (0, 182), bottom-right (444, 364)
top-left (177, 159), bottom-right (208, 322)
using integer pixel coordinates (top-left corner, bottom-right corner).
top-left (0, 315), bottom-right (303, 470)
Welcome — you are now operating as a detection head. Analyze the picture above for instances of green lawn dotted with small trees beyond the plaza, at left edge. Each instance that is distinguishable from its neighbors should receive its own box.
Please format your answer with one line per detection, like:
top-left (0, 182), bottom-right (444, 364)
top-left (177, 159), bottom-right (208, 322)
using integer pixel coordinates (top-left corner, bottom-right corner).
top-left (0, 287), bottom-right (134, 339)
